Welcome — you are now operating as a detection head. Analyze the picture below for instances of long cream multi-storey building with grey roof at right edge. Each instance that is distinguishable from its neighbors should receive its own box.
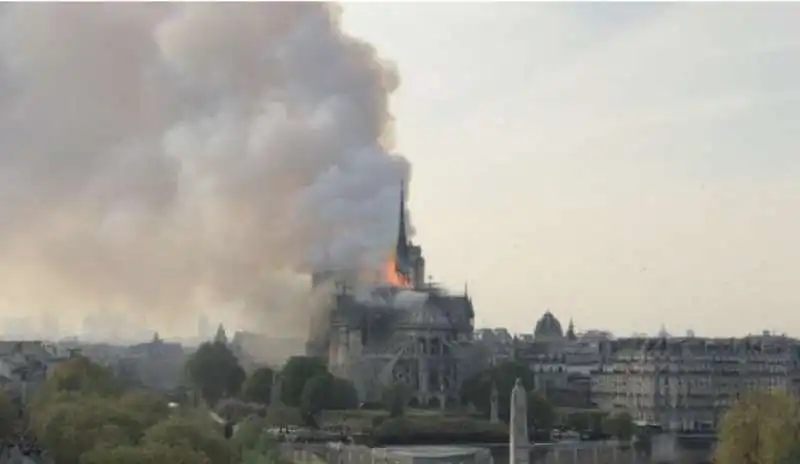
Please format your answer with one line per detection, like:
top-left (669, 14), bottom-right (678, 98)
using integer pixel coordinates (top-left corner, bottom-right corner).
top-left (592, 334), bottom-right (798, 431)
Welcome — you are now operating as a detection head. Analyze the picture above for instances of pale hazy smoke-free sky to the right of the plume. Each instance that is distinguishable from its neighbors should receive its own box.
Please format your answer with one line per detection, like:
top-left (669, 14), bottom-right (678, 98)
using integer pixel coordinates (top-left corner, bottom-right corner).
top-left (345, 3), bottom-right (800, 335)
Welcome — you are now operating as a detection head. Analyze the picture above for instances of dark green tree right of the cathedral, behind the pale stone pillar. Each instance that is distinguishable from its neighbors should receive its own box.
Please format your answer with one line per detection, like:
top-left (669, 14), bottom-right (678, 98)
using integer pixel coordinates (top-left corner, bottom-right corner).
top-left (461, 361), bottom-right (534, 422)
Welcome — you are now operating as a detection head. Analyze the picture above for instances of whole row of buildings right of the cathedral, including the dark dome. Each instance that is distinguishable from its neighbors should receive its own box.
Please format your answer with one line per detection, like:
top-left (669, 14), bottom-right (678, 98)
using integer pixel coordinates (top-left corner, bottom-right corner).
top-left (477, 311), bottom-right (800, 431)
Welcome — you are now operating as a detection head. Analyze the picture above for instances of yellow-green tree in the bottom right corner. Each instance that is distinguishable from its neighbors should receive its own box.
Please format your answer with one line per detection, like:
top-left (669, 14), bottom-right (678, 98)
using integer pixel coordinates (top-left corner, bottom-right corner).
top-left (714, 390), bottom-right (800, 464)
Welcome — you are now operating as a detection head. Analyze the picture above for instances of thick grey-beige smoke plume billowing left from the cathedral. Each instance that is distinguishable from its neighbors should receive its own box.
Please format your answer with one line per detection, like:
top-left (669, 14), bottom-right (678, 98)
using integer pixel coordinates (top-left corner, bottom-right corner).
top-left (0, 3), bottom-right (409, 336)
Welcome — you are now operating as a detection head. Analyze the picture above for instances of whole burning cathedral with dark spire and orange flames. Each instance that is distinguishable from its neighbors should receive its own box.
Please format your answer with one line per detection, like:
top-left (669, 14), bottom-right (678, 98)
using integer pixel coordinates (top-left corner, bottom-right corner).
top-left (307, 185), bottom-right (481, 407)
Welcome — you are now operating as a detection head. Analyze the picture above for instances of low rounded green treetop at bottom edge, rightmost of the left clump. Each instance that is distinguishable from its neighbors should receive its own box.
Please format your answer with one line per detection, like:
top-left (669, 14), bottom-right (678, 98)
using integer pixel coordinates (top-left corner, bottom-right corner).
top-left (142, 416), bottom-right (232, 464)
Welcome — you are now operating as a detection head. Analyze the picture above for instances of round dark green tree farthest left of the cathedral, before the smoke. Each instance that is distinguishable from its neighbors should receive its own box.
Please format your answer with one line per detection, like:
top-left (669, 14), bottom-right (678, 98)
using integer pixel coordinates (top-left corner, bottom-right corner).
top-left (186, 341), bottom-right (245, 406)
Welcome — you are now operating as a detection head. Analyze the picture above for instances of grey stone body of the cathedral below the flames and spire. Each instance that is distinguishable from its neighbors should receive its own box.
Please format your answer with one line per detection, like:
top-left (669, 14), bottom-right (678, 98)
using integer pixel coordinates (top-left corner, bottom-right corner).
top-left (327, 286), bottom-right (479, 407)
